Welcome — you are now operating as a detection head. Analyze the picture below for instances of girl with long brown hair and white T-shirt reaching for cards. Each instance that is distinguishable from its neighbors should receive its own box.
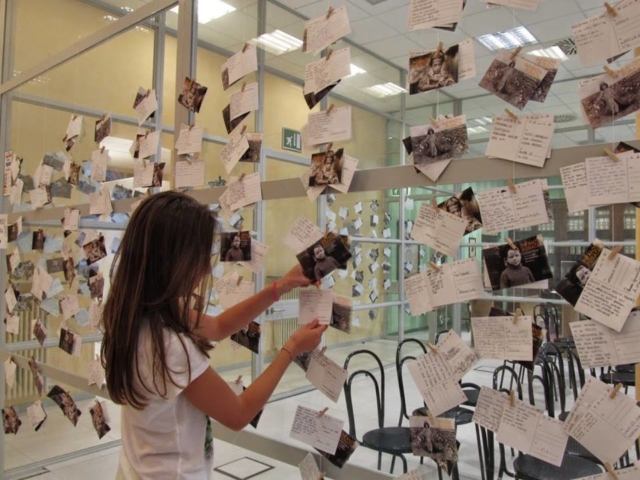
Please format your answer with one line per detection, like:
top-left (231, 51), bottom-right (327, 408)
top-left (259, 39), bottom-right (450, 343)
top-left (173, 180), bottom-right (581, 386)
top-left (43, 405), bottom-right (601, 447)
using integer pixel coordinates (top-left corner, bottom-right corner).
top-left (101, 192), bottom-right (326, 480)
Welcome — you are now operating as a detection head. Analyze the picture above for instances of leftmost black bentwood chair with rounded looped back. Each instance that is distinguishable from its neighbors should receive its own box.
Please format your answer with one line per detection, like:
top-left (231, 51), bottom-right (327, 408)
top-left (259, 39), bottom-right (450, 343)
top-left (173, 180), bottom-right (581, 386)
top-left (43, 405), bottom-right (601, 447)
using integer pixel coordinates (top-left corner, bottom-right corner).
top-left (343, 350), bottom-right (413, 473)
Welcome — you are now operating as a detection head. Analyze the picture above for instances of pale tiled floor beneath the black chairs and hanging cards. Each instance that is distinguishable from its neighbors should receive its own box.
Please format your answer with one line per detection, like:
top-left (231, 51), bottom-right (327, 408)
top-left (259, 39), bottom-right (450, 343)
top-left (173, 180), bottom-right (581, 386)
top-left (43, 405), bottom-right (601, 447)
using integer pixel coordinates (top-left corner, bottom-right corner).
top-left (5, 341), bottom-right (633, 480)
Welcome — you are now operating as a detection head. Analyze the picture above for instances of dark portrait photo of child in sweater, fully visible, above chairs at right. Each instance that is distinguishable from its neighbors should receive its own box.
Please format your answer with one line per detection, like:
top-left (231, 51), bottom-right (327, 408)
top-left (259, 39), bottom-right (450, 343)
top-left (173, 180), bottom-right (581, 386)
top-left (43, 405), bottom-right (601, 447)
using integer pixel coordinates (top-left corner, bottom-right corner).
top-left (482, 235), bottom-right (553, 291)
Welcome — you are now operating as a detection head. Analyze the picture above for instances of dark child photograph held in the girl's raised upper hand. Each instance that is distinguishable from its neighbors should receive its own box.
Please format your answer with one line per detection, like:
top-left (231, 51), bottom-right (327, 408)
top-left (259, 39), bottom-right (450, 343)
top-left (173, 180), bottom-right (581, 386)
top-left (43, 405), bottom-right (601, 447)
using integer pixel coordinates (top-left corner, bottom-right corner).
top-left (296, 232), bottom-right (351, 282)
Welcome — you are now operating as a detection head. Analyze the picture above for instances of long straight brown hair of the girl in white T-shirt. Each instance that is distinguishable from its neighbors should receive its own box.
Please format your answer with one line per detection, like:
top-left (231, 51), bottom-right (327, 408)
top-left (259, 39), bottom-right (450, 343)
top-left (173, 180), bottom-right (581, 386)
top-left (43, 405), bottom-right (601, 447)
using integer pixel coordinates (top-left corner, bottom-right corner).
top-left (101, 192), bottom-right (217, 409)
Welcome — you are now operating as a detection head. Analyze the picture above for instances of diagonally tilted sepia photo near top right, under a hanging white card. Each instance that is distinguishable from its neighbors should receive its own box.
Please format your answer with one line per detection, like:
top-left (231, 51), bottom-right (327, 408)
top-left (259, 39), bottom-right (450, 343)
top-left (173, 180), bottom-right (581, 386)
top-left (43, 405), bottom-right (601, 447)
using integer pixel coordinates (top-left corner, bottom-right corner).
top-left (480, 50), bottom-right (547, 110)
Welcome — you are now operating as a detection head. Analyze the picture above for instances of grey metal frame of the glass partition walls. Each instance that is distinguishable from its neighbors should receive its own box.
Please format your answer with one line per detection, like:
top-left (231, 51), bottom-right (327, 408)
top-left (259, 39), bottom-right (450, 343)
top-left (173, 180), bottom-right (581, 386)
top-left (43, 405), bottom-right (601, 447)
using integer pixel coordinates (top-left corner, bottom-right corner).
top-left (0, 0), bottom-right (640, 474)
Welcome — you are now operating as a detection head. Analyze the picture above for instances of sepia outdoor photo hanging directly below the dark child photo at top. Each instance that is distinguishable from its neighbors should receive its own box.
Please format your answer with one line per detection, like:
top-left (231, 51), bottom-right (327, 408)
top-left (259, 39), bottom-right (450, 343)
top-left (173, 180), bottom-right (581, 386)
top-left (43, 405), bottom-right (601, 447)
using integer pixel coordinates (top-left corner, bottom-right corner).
top-left (410, 115), bottom-right (469, 165)
